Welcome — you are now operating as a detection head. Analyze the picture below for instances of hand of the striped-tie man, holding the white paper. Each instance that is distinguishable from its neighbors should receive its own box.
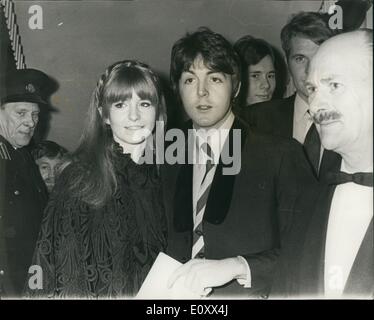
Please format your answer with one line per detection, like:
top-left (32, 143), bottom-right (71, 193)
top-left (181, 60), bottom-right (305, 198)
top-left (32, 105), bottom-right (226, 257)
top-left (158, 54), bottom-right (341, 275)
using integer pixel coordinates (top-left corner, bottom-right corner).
top-left (167, 257), bottom-right (246, 297)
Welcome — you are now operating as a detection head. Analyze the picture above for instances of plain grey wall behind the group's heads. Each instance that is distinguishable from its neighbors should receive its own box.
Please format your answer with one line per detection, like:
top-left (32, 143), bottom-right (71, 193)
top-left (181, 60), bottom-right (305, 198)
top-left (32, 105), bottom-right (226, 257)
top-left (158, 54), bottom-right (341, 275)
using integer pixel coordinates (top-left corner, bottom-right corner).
top-left (8, 0), bottom-right (372, 149)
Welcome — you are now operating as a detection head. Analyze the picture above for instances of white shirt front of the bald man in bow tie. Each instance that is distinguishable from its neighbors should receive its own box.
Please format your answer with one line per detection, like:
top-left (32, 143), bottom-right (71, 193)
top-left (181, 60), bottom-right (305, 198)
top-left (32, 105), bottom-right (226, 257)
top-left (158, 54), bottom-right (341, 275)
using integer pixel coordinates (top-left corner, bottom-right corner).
top-left (324, 162), bottom-right (373, 298)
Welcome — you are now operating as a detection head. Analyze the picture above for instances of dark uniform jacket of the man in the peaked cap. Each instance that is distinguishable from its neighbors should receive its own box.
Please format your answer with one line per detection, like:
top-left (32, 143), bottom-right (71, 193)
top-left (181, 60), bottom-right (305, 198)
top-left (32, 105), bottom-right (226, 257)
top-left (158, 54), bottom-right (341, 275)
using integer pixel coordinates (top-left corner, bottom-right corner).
top-left (0, 135), bottom-right (47, 297)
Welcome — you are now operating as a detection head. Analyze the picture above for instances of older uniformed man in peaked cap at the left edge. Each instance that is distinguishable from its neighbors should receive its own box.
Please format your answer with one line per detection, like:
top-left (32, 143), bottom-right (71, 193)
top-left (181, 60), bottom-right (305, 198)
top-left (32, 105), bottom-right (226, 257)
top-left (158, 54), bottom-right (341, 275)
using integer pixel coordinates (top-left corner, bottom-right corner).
top-left (0, 69), bottom-right (48, 298)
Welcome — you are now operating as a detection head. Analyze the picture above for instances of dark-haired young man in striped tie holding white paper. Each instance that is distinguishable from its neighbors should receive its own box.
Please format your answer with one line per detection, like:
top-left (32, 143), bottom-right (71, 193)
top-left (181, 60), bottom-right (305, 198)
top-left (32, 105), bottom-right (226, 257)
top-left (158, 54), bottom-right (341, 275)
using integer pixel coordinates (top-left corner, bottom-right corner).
top-left (163, 28), bottom-right (313, 298)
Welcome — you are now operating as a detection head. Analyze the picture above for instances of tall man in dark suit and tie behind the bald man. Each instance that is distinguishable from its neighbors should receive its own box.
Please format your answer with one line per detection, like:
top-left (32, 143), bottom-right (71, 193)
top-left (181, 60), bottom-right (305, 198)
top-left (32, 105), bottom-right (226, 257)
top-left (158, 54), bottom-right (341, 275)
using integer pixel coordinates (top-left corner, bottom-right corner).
top-left (241, 12), bottom-right (340, 177)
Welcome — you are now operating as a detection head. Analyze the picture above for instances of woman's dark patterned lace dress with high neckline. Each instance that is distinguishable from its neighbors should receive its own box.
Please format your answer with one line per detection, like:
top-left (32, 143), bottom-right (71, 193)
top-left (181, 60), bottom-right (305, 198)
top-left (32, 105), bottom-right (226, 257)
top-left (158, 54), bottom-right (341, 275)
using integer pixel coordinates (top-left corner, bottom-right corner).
top-left (31, 144), bottom-right (166, 298)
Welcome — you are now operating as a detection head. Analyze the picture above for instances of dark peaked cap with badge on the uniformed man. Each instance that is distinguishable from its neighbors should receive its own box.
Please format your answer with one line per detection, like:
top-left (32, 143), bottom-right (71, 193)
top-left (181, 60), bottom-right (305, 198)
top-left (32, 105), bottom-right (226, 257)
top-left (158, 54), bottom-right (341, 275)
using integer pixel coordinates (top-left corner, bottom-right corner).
top-left (0, 69), bottom-right (49, 105)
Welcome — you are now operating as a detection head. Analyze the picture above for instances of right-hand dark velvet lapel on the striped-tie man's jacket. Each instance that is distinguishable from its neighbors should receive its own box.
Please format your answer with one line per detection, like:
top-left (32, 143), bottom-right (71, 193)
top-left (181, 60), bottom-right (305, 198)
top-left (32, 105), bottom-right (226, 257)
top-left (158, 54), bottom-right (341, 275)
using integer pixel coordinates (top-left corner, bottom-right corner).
top-left (204, 118), bottom-right (248, 224)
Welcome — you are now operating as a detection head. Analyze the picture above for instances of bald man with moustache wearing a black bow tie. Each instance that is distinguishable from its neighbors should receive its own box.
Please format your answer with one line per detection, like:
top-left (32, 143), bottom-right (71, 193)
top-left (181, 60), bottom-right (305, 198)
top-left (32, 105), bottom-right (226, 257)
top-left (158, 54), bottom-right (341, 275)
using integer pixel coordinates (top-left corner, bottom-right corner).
top-left (273, 30), bottom-right (374, 298)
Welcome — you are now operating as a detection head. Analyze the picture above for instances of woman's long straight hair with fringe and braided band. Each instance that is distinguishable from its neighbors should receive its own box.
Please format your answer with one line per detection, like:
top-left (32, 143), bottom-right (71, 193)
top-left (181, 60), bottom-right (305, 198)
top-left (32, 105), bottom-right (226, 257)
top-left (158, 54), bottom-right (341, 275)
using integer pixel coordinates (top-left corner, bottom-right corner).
top-left (65, 60), bottom-right (166, 208)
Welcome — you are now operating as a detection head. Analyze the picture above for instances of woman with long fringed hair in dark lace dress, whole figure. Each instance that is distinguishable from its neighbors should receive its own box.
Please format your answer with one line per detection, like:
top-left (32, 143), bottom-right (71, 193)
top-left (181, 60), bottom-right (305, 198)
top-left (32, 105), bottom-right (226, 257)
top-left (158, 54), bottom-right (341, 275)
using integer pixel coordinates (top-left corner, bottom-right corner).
top-left (28, 60), bottom-right (166, 298)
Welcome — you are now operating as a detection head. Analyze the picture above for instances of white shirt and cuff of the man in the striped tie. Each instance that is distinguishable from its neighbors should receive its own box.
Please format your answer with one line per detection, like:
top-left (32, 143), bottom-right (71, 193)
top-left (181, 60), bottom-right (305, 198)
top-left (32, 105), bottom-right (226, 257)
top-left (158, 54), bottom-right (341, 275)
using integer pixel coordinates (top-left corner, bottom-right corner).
top-left (192, 111), bottom-right (251, 288)
